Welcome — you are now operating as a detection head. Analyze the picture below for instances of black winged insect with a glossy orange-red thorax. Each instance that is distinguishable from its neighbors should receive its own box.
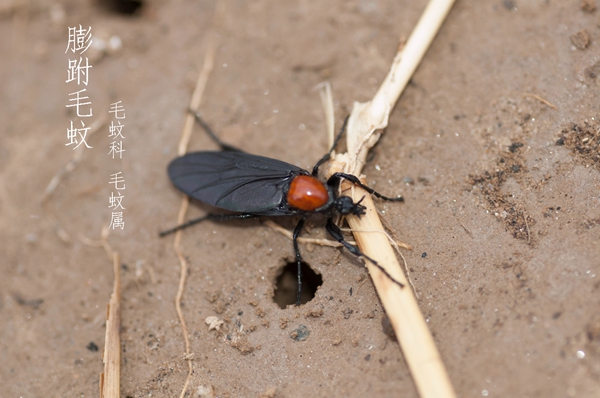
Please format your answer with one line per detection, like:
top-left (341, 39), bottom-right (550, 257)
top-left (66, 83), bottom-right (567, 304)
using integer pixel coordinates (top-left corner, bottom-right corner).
top-left (160, 113), bottom-right (404, 305)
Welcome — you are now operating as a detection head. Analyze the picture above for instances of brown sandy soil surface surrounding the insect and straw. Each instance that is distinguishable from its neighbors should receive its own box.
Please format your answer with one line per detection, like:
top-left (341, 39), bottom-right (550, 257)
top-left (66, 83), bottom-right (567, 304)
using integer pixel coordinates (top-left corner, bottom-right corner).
top-left (0, 0), bottom-right (600, 398)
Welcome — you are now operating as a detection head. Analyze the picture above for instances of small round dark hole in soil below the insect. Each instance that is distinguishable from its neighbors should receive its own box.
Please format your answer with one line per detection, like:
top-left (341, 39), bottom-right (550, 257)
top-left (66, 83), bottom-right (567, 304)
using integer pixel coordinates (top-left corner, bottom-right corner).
top-left (273, 262), bottom-right (323, 309)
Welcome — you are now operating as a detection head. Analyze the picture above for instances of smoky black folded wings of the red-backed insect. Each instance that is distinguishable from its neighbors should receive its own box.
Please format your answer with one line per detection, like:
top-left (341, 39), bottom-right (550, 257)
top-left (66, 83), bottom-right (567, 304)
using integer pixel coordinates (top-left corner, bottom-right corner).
top-left (168, 151), bottom-right (309, 215)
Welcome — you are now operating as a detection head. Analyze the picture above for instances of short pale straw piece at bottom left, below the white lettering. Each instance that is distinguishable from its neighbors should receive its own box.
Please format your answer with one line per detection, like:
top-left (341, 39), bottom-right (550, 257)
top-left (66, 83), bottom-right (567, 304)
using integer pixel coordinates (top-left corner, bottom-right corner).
top-left (100, 252), bottom-right (121, 398)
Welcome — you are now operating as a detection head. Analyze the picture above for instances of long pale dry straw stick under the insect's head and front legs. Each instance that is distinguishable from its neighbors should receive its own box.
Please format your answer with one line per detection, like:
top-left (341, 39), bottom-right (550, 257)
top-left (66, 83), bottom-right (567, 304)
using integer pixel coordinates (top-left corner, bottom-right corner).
top-left (330, 0), bottom-right (455, 398)
